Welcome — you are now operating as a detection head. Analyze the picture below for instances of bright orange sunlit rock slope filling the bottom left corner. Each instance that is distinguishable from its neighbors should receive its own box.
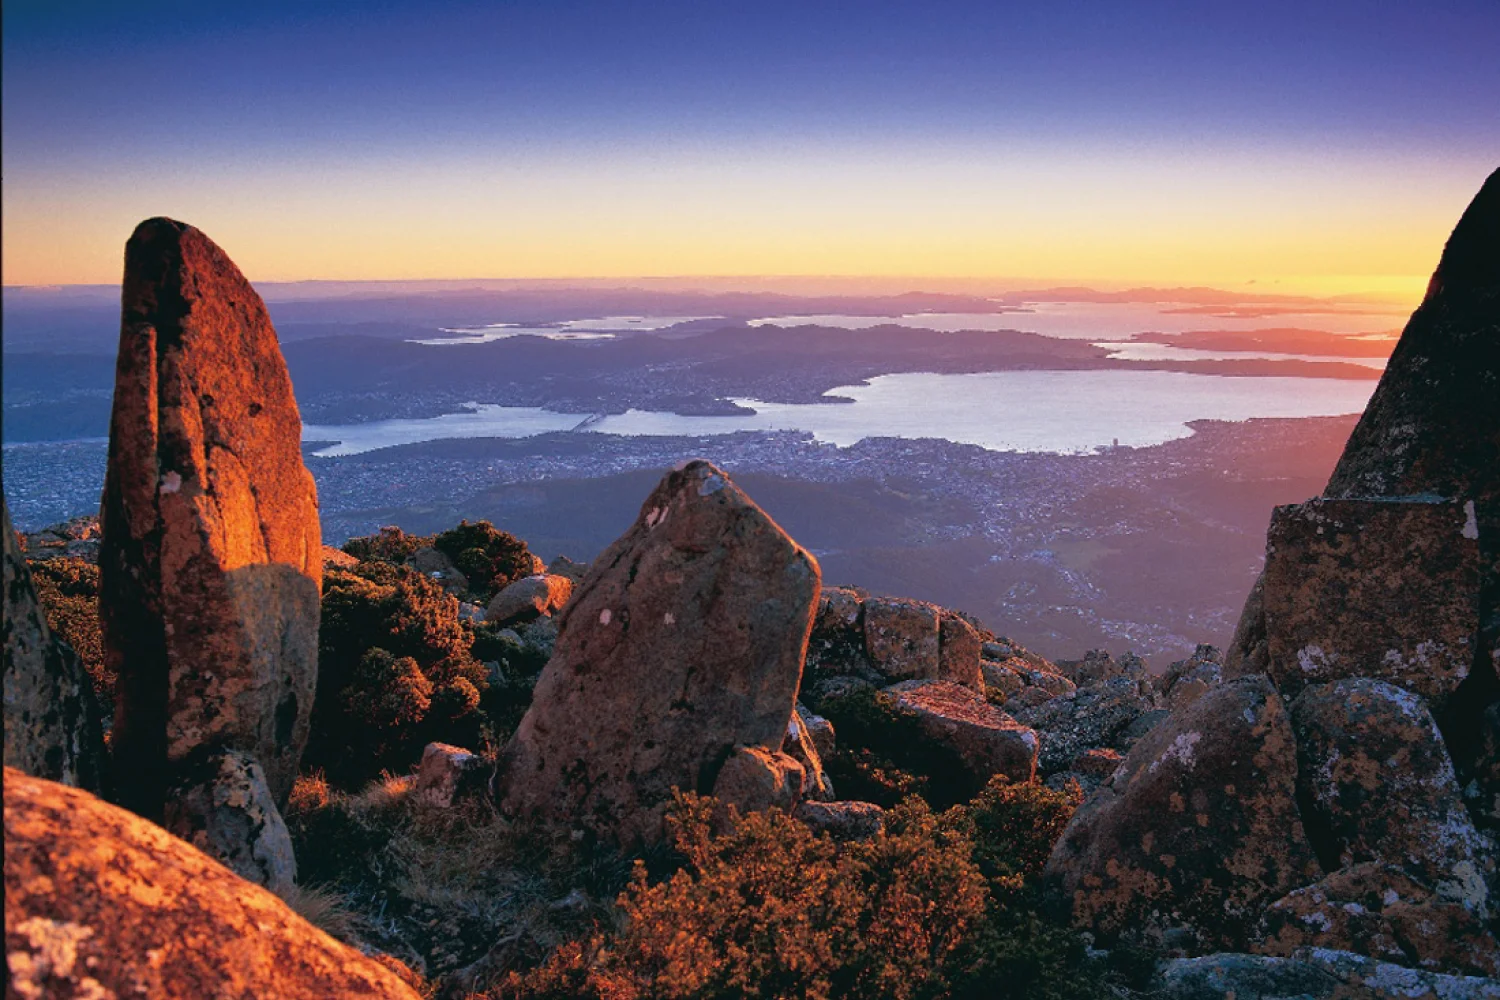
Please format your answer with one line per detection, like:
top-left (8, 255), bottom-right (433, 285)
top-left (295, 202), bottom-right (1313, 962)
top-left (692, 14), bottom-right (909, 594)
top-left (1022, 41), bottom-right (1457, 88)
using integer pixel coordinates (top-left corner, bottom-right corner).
top-left (5, 768), bottom-right (417, 1000)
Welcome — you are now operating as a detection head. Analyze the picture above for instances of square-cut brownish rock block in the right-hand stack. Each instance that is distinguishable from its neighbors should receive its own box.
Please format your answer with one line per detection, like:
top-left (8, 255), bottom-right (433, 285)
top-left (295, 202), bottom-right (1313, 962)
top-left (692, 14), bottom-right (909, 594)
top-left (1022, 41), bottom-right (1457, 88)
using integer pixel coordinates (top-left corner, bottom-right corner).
top-left (1263, 499), bottom-right (1481, 708)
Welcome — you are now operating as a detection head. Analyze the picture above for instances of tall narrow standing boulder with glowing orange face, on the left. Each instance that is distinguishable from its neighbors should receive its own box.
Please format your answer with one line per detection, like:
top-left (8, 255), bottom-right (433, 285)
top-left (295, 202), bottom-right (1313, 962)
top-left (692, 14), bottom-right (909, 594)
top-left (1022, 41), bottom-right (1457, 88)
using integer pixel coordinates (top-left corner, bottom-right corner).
top-left (99, 219), bottom-right (323, 817)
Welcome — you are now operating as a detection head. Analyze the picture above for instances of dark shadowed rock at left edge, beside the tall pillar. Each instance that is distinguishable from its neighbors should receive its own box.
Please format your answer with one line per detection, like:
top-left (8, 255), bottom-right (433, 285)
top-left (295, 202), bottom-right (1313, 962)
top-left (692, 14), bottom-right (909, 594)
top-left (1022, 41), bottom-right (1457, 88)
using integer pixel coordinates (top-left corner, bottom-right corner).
top-left (0, 505), bottom-right (105, 792)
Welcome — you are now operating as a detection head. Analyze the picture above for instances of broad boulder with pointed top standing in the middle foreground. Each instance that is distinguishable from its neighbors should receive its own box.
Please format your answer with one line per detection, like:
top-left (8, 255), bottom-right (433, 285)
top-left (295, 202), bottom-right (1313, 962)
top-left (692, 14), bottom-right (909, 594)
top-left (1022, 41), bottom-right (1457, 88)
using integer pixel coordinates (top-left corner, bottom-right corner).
top-left (501, 462), bottom-right (819, 846)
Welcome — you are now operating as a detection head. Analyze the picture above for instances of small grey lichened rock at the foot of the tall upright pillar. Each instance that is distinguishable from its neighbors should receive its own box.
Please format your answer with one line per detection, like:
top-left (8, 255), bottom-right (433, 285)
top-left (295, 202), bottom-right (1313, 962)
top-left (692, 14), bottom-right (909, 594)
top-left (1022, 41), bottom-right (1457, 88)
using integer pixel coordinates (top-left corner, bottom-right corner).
top-left (162, 750), bottom-right (297, 894)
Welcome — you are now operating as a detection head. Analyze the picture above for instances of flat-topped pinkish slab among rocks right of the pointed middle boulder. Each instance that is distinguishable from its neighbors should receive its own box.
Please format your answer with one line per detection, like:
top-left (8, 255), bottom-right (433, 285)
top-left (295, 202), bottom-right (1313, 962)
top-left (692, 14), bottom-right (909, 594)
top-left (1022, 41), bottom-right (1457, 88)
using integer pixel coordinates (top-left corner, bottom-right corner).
top-left (885, 681), bottom-right (1037, 781)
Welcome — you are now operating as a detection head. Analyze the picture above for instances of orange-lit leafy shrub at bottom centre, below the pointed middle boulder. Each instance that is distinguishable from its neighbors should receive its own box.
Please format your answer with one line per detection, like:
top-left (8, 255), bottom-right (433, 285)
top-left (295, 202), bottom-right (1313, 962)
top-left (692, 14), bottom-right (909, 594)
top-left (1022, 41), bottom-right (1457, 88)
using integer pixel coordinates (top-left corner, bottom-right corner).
top-left (492, 795), bottom-right (986, 1000)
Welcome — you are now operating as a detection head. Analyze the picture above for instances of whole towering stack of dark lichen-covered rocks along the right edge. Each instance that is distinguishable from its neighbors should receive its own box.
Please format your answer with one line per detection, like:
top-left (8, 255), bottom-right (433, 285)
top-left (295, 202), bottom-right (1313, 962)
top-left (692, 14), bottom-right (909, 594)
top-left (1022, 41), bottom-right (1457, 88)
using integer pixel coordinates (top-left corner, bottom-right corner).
top-left (1049, 171), bottom-right (1500, 971)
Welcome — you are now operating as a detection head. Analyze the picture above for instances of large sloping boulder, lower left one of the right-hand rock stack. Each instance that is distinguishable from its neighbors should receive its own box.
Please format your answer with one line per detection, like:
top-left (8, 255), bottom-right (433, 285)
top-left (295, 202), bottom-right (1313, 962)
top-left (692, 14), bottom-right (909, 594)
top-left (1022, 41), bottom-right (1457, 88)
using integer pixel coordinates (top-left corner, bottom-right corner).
top-left (1047, 678), bottom-right (1320, 949)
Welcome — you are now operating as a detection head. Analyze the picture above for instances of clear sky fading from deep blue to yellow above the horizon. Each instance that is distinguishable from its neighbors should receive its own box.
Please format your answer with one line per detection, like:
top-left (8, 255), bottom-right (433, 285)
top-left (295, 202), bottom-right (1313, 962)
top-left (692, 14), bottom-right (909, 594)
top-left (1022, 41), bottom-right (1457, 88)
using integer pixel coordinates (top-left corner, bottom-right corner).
top-left (0, 0), bottom-right (1500, 298)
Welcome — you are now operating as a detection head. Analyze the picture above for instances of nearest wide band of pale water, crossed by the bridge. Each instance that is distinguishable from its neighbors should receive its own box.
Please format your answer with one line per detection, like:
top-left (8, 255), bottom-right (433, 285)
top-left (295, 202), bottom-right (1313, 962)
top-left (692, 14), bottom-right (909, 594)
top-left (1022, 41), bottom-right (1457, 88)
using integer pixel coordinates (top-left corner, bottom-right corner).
top-left (303, 370), bottom-right (1376, 457)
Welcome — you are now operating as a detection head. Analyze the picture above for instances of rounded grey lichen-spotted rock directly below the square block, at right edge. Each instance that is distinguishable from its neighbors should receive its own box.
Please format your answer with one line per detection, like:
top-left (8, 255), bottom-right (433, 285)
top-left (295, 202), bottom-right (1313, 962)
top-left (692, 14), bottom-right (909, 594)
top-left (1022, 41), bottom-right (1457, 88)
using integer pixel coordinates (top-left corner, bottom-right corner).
top-left (1292, 678), bottom-right (1494, 915)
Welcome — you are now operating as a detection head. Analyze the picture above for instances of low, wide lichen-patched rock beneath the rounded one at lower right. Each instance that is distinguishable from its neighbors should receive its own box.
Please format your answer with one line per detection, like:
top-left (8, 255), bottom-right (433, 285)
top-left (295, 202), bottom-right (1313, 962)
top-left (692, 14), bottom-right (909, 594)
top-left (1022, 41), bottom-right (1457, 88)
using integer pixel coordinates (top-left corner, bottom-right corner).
top-left (1254, 862), bottom-right (1500, 976)
